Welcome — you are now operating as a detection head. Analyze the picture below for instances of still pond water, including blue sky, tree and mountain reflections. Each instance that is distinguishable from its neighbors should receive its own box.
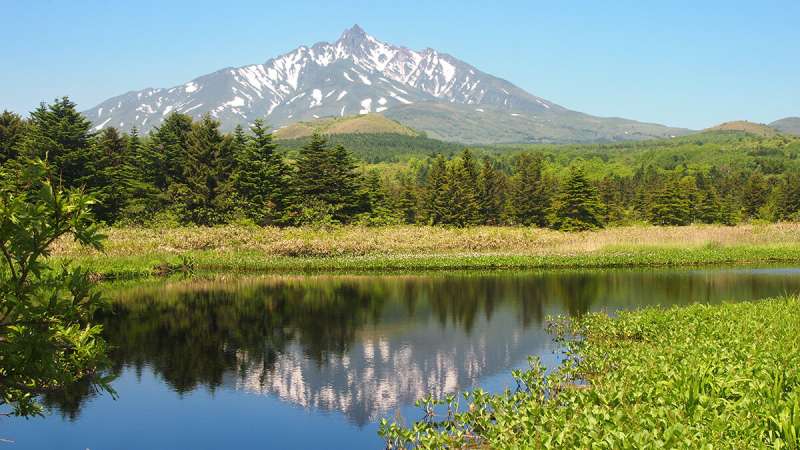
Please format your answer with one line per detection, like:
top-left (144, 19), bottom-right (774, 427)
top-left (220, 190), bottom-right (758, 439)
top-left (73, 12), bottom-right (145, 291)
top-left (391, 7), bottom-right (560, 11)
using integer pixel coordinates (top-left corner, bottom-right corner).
top-left (0, 268), bottom-right (800, 450)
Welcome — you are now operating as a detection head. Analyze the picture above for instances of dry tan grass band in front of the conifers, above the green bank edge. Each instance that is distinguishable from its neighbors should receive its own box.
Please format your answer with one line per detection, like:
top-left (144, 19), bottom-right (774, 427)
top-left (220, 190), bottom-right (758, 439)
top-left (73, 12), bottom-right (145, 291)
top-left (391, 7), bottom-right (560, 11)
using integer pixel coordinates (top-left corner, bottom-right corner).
top-left (53, 223), bottom-right (800, 257)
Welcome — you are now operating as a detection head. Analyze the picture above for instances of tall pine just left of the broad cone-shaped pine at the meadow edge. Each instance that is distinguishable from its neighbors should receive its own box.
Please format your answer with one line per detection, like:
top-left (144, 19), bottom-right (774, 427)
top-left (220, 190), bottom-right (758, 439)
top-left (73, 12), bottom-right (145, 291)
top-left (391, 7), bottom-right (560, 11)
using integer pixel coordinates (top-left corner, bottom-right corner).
top-left (506, 153), bottom-right (551, 227)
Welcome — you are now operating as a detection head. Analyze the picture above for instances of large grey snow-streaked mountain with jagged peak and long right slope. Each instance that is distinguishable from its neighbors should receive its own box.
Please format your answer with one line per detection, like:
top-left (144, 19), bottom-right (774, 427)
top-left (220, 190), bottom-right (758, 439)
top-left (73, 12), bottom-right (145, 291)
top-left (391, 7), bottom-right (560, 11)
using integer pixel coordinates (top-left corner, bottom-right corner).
top-left (85, 25), bottom-right (688, 143)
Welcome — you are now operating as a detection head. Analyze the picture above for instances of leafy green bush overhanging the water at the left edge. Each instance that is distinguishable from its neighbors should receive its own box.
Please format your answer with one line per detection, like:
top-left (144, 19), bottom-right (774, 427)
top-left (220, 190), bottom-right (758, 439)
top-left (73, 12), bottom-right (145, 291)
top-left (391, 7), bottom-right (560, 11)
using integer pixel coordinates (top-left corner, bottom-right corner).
top-left (0, 161), bottom-right (111, 416)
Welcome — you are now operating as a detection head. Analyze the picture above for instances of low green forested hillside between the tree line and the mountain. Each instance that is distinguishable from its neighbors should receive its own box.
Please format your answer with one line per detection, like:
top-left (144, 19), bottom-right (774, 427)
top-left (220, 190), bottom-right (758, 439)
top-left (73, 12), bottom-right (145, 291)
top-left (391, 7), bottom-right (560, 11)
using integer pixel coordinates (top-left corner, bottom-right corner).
top-left (278, 126), bottom-right (800, 174)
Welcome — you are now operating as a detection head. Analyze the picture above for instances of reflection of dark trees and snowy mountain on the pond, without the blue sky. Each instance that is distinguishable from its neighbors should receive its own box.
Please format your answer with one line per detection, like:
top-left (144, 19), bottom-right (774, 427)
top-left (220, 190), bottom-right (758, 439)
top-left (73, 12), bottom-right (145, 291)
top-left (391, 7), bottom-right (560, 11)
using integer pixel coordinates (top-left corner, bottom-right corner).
top-left (40, 269), bottom-right (800, 425)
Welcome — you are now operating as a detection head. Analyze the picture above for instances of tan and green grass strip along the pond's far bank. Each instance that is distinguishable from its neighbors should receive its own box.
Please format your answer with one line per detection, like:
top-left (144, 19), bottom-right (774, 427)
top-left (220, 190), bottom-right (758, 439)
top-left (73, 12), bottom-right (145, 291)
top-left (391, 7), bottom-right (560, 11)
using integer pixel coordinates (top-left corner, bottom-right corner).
top-left (47, 224), bottom-right (800, 278)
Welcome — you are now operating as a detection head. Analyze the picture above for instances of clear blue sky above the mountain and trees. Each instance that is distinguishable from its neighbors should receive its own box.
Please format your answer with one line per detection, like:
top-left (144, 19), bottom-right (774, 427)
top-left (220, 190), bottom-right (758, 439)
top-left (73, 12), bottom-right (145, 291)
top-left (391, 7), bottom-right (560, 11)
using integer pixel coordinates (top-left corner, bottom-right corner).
top-left (0, 0), bottom-right (800, 128)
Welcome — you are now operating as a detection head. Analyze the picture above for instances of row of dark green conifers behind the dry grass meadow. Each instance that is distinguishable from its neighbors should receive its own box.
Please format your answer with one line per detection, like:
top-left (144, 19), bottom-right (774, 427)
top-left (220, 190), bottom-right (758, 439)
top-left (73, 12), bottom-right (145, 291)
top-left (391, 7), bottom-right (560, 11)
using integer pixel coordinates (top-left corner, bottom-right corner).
top-left (0, 98), bottom-right (800, 230)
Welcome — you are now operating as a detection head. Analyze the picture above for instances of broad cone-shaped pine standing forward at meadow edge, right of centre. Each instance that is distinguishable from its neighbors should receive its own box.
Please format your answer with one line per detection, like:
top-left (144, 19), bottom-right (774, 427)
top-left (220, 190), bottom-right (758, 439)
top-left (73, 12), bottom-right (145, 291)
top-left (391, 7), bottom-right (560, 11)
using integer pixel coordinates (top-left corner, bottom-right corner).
top-left (553, 166), bottom-right (603, 231)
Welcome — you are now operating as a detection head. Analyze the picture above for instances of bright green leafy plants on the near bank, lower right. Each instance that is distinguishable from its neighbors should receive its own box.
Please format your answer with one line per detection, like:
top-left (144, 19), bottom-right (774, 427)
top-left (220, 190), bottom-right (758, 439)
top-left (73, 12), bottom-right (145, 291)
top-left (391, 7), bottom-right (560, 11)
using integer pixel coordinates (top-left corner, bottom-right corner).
top-left (381, 298), bottom-right (800, 449)
